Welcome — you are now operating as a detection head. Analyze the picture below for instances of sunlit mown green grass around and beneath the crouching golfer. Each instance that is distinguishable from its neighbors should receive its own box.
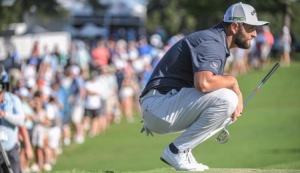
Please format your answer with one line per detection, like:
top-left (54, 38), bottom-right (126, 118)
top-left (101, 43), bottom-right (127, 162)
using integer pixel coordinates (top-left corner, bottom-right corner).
top-left (54, 62), bottom-right (300, 173)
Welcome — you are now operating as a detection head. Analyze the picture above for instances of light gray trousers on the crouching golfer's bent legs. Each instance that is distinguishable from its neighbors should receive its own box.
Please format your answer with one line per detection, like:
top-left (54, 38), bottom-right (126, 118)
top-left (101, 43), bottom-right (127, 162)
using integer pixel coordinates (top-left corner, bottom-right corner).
top-left (140, 88), bottom-right (238, 150)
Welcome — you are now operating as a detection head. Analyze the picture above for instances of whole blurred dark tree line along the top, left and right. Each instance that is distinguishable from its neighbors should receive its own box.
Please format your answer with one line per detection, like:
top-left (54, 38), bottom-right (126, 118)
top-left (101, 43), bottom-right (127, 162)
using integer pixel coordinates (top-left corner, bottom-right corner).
top-left (0, 0), bottom-right (300, 39)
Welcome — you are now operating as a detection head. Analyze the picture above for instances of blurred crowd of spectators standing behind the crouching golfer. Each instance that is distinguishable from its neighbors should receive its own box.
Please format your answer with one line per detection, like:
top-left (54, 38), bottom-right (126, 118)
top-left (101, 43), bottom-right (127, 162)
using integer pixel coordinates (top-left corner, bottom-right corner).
top-left (2, 23), bottom-right (290, 172)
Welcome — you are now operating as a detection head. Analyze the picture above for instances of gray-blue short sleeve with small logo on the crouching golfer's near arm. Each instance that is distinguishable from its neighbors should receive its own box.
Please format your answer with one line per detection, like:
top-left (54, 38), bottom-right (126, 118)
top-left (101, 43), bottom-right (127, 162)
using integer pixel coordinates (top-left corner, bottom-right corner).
top-left (191, 40), bottom-right (226, 74)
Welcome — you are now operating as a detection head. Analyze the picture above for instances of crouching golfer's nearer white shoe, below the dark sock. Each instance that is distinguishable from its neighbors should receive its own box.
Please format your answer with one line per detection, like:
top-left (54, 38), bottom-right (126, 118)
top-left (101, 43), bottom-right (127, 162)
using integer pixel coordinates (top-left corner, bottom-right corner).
top-left (160, 146), bottom-right (204, 172)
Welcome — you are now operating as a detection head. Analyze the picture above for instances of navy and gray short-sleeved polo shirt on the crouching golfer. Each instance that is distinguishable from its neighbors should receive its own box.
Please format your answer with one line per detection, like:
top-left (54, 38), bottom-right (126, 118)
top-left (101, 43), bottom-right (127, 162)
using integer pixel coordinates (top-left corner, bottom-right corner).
top-left (141, 23), bottom-right (230, 96)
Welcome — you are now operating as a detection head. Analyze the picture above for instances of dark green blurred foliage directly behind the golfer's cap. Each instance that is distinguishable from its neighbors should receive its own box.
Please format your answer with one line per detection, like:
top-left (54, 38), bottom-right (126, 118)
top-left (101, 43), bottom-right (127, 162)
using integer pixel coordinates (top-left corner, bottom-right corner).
top-left (147, 0), bottom-right (300, 38)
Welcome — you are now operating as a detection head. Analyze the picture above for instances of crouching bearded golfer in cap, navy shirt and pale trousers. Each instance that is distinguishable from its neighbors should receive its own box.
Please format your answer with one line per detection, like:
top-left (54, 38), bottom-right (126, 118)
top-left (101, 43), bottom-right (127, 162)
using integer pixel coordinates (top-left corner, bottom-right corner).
top-left (139, 2), bottom-right (268, 171)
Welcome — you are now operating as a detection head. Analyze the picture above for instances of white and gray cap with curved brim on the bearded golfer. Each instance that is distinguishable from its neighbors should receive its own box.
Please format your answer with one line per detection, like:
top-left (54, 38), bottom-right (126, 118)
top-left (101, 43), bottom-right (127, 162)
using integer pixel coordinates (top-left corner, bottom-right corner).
top-left (223, 2), bottom-right (269, 26)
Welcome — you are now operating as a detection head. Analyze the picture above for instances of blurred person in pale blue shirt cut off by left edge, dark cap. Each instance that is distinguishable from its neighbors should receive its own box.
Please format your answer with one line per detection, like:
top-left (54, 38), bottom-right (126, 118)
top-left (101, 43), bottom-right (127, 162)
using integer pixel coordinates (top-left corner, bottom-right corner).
top-left (0, 65), bottom-right (25, 173)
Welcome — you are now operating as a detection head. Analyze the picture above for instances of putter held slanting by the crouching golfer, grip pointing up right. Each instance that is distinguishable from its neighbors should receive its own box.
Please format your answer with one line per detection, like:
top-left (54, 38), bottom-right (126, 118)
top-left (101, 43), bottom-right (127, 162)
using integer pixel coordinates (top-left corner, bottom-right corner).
top-left (216, 63), bottom-right (279, 144)
